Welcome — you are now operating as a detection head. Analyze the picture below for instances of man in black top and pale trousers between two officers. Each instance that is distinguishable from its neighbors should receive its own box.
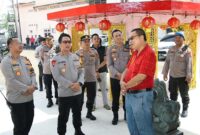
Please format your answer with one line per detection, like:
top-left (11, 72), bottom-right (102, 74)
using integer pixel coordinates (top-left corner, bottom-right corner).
top-left (91, 33), bottom-right (110, 110)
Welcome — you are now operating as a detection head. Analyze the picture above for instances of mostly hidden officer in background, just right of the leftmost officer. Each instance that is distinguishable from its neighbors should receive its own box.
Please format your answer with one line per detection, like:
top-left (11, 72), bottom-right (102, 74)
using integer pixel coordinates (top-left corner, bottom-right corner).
top-left (35, 37), bottom-right (46, 91)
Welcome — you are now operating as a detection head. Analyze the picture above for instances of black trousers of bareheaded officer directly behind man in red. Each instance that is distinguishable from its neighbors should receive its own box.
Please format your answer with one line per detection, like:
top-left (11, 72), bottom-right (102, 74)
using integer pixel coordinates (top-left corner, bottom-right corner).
top-left (110, 78), bottom-right (126, 113)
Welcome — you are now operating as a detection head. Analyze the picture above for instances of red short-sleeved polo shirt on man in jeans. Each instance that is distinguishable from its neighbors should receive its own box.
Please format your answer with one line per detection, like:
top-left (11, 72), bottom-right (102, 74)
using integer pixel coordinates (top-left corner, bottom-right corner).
top-left (124, 45), bottom-right (156, 90)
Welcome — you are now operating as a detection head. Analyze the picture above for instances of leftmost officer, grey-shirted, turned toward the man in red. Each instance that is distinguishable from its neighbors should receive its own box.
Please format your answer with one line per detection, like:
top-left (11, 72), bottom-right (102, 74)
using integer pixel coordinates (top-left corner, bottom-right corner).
top-left (1, 38), bottom-right (37, 135)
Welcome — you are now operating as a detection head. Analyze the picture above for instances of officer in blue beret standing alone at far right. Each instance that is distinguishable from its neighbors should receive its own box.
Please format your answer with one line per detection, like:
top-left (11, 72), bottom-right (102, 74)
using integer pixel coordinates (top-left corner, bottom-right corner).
top-left (162, 32), bottom-right (192, 117)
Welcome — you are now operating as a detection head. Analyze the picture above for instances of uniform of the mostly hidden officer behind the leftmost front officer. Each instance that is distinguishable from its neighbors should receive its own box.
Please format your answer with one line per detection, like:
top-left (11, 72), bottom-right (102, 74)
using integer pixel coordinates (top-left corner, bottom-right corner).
top-left (35, 45), bottom-right (43, 91)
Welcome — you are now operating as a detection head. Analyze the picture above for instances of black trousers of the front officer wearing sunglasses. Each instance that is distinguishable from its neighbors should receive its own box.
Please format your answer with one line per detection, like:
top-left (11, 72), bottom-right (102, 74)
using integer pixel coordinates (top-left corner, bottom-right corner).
top-left (57, 94), bottom-right (82, 135)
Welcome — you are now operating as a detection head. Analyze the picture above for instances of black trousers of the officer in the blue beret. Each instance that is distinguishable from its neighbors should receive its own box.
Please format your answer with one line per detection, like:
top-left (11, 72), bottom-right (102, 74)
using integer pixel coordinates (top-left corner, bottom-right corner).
top-left (169, 77), bottom-right (190, 110)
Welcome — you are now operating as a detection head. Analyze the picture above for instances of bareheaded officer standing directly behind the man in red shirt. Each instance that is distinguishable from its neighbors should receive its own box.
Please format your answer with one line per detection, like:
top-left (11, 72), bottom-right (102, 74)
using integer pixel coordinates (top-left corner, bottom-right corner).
top-left (107, 29), bottom-right (130, 125)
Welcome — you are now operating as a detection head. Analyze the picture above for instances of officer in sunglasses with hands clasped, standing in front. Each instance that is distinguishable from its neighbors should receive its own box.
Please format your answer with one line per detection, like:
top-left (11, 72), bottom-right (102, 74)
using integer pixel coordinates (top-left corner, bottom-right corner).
top-left (51, 33), bottom-right (84, 135)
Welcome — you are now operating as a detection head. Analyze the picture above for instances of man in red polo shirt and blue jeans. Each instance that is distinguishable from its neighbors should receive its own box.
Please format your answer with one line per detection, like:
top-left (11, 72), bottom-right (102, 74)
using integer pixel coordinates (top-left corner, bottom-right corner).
top-left (120, 28), bottom-right (156, 135)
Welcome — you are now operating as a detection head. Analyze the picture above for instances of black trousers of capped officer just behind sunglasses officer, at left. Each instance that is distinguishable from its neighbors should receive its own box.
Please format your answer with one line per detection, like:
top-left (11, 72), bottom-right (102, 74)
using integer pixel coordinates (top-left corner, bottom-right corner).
top-left (44, 74), bottom-right (58, 99)
